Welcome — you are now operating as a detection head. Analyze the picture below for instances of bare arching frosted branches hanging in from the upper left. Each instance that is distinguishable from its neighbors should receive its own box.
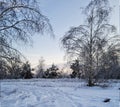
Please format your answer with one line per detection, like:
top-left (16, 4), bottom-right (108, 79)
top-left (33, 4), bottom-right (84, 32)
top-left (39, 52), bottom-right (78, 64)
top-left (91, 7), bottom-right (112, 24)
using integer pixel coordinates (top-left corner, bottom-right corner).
top-left (0, 0), bottom-right (52, 59)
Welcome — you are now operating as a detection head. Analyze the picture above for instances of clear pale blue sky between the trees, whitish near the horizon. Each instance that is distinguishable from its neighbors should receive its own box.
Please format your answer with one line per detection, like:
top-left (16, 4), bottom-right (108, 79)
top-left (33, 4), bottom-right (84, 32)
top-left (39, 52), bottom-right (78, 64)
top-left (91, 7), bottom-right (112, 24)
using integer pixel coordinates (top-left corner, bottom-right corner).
top-left (19, 0), bottom-right (119, 67)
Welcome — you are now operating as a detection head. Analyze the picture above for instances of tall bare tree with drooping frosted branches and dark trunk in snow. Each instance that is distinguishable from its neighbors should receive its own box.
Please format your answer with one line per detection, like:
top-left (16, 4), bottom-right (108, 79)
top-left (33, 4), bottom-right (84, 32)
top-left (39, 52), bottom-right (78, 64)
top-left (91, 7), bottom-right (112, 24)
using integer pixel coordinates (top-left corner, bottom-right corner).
top-left (62, 0), bottom-right (120, 86)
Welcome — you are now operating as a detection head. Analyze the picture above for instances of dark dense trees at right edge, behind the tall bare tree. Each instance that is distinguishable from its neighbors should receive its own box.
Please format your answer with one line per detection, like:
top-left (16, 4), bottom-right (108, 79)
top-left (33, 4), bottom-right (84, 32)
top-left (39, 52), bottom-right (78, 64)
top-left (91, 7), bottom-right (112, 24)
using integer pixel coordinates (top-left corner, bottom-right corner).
top-left (97, 49), bottom-right (120, 79)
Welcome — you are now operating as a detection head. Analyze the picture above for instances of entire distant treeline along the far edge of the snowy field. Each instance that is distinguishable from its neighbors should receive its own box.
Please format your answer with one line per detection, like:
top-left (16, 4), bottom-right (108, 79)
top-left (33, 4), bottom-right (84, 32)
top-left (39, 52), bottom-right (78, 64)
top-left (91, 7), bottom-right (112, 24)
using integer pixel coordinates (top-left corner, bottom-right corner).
top-left (0, 53), bottom-right (120, 82)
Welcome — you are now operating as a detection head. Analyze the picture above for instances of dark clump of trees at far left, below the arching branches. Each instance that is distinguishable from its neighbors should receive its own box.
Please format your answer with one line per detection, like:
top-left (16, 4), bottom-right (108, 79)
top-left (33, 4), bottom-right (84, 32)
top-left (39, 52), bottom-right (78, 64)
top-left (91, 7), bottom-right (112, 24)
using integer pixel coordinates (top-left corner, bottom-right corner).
top-left (0, 60), bottom-right (33, 79)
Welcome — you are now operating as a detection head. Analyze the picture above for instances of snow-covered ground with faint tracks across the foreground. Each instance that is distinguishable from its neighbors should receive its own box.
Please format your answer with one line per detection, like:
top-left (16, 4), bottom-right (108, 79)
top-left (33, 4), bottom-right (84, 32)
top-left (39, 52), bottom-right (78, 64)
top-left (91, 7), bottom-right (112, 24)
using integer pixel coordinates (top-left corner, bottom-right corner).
top-left (0, 79), bottom-right (120, 107)
